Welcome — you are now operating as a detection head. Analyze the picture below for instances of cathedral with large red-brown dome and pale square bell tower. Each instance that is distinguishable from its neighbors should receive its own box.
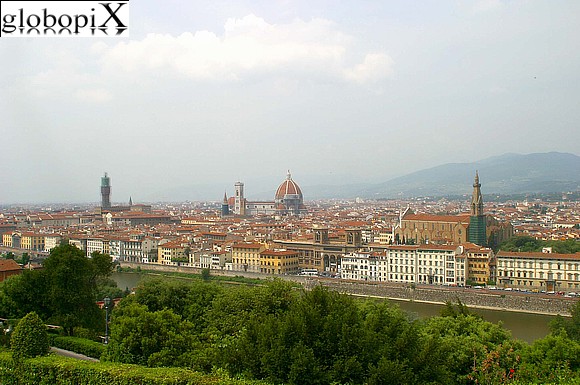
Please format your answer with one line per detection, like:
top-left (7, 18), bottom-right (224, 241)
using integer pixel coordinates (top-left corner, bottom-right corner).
top-left (229, 171), bottom-right (306, 216)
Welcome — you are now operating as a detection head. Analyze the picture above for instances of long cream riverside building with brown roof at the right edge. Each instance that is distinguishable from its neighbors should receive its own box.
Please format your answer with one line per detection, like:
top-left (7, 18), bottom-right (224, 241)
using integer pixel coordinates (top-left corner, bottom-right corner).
top-left (496, 251), bottom-right (580, 291)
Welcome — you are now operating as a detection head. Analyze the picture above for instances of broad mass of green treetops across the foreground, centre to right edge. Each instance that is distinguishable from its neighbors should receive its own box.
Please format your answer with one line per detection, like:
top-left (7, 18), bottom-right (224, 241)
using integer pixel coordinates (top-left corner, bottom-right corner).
top-left (102, 280), bottom-right (580, 384)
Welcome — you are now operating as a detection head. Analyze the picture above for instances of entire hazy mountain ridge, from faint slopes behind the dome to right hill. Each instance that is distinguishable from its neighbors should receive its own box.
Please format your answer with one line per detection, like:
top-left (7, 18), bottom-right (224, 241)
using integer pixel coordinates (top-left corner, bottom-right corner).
top-left (147, 152), bottom-right (580, 202)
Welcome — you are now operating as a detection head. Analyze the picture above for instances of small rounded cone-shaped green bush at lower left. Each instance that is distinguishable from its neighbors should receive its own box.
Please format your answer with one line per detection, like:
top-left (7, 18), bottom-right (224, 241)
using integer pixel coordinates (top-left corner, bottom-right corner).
top-left (10, 312), bottom-right (49, 361)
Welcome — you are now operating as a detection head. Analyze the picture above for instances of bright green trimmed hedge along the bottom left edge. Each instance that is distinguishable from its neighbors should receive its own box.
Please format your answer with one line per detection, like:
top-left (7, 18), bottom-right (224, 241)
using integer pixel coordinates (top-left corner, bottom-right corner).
top-left (0, 352), bottom-right (265, 385)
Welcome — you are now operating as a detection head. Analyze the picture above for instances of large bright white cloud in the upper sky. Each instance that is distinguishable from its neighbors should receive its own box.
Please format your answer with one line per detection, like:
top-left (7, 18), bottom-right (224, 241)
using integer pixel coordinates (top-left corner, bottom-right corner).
top-left (93, 15), bottom-right (393, 83)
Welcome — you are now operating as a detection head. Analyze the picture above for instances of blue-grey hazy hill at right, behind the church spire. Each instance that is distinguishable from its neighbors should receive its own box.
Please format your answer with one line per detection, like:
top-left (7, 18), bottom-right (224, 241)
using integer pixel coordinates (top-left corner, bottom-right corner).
top-left (358, 152), bottom-right (580, 198)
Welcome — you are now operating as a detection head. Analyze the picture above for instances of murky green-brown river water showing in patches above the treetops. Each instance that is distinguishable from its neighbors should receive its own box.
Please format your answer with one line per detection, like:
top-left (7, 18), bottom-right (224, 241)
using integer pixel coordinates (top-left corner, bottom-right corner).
top-left (111, 273), bottom-right (554, 343)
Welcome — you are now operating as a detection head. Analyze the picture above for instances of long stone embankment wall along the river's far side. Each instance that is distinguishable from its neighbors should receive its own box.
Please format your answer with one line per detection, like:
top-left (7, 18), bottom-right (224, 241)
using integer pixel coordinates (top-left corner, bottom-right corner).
top-left (121, 263), bottom-right (578, 316)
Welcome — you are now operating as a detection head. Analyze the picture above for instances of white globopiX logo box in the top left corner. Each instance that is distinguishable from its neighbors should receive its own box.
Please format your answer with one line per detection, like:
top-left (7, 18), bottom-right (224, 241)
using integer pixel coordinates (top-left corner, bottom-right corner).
top-left (0, 1), bottom-right (129, 37)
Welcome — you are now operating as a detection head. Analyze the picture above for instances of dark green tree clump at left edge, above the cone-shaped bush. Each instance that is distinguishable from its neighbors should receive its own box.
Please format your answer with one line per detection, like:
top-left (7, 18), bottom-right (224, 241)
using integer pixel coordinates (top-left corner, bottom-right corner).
top-left (0, 243), bottom-right (119, 335)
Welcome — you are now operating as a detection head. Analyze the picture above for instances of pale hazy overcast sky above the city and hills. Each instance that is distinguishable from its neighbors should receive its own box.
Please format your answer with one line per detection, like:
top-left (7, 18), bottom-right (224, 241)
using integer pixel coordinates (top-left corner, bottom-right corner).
top-left (0, 0), bottom-right (580, 204)
